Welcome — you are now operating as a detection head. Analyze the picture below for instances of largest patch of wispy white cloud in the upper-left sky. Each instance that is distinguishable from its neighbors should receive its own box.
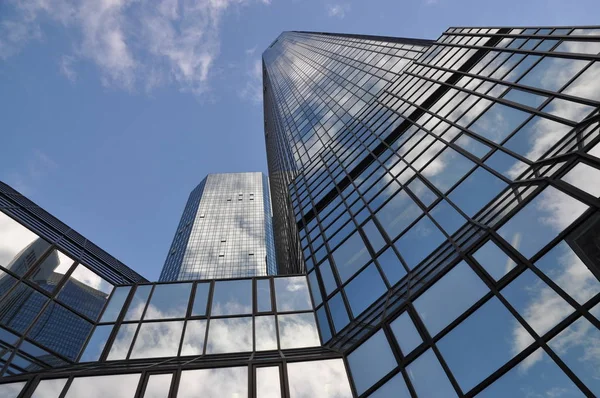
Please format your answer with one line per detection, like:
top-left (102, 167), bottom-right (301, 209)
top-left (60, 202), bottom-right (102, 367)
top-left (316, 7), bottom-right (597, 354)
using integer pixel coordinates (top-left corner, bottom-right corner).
top-left (0, 0), bottom-right (270, 93)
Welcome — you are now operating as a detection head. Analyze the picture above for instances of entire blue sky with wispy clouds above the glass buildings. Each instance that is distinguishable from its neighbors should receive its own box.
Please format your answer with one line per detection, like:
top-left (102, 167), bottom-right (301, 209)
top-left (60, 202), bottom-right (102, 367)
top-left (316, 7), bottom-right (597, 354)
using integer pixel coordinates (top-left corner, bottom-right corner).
top-left (0, 0), bottom-right (600, 280)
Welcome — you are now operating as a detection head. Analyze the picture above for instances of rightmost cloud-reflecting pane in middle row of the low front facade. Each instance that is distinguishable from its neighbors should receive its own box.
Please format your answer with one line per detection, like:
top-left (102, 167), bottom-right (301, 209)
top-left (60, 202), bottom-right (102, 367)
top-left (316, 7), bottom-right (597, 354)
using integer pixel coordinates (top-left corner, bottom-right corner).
top-left (277, 312), bottom-right (321, 349)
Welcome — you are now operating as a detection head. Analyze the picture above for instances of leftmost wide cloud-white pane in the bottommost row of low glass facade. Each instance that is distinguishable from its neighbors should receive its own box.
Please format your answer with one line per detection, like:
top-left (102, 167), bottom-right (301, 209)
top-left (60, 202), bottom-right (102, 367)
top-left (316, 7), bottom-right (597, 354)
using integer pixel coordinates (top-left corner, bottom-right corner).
top-left (65, 374), bottom-right (140, 398)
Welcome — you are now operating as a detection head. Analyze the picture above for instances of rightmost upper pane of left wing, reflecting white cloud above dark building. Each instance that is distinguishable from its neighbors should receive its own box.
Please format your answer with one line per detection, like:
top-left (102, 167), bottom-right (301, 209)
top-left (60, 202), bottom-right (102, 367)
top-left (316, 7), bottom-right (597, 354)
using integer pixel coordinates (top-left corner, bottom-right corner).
top-left (58, 264), bottom-right (113, 320)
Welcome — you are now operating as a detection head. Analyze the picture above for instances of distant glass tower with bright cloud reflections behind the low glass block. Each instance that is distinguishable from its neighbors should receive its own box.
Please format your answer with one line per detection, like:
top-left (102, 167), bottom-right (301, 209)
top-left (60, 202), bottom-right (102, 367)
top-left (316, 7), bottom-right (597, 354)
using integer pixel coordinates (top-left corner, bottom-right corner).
top-left (160, 173), bottom-right (277, 282)
